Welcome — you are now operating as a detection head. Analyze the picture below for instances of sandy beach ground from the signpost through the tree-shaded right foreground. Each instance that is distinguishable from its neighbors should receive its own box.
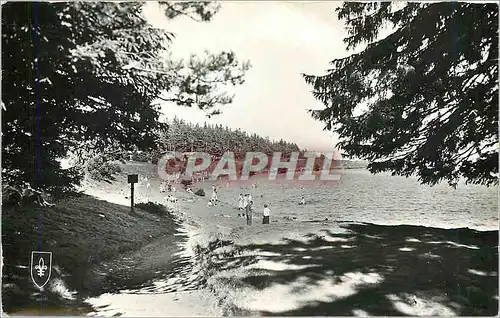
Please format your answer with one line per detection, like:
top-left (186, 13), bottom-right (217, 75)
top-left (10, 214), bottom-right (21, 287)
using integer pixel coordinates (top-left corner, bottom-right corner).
top-left (80, 164), bottom-right (498, 316)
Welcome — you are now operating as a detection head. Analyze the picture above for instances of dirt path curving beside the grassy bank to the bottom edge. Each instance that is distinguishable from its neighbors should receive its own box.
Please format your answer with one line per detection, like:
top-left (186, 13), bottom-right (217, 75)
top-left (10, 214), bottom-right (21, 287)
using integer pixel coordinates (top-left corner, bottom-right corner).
top-left (81, 176), bottom-right (226, 317)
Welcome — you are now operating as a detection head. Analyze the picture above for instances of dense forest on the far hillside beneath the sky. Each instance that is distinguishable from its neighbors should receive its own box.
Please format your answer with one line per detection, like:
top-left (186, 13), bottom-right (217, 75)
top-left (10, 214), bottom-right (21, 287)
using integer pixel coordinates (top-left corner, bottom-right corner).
top-left (78, 118), bottom-right (302, 180)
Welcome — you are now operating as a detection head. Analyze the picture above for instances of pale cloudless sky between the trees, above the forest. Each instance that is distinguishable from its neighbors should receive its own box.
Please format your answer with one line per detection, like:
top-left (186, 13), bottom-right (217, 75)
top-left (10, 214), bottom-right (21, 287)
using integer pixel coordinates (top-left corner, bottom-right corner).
top-left (144, 1), bottom-right (347, 151)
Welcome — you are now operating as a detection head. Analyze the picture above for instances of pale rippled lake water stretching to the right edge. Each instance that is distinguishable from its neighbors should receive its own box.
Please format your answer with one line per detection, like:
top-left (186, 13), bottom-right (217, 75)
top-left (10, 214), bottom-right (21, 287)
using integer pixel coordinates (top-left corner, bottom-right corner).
top-left (233, 170), bottom-right (498, 230)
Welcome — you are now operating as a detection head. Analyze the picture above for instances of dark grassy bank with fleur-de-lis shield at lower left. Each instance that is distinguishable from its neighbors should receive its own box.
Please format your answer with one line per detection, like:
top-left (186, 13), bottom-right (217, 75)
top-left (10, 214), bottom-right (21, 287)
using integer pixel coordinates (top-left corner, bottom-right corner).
top-left (2, 195), bottom-right (182, 314)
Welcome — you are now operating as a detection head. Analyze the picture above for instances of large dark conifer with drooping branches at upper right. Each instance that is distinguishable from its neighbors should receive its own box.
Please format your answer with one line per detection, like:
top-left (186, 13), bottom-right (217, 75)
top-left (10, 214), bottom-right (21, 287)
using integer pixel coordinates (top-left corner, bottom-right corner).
top-left (305, 2), bottom-right (498, 186)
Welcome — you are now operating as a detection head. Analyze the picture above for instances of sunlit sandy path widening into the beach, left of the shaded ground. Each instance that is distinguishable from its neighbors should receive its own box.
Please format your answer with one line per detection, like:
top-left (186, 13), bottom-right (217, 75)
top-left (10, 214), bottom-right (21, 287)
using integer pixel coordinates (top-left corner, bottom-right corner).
top-left (79, 164), bottom-right (344, 316)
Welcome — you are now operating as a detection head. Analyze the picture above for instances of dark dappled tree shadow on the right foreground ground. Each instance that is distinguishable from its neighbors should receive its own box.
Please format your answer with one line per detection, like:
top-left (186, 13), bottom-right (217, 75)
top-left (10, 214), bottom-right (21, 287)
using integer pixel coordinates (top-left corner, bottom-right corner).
top-left (206, 224), bottom-right (498, 316)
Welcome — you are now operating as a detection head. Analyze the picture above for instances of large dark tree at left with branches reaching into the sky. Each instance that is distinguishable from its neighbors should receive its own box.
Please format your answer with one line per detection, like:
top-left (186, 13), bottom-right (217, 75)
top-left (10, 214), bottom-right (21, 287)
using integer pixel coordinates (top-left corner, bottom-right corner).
top-left (2, 2), bottom-right (249, 191)
